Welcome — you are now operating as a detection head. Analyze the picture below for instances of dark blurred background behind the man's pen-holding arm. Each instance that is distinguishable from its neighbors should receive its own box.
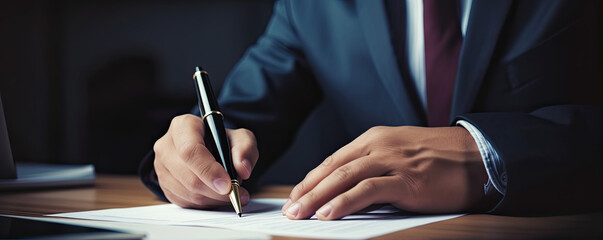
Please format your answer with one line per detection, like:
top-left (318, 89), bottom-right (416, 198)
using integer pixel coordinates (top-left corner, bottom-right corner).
top-left (0, 0), bottom-right (341, 183)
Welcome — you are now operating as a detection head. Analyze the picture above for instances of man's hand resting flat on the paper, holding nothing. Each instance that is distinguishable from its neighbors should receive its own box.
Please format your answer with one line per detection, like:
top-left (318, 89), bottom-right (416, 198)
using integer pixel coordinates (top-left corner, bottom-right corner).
top-left (282, 127), bottom-right (488, 220)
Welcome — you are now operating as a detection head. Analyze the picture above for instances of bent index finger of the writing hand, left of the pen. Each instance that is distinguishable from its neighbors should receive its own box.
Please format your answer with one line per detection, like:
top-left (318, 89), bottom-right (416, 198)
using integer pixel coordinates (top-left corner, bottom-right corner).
top-left (170, 114), bottom-right (231, 195)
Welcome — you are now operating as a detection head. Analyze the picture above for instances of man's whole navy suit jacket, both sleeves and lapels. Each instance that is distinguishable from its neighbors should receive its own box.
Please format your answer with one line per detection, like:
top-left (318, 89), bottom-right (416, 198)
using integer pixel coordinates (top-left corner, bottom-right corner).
top-left (141, 0), bottom-right (603, 214)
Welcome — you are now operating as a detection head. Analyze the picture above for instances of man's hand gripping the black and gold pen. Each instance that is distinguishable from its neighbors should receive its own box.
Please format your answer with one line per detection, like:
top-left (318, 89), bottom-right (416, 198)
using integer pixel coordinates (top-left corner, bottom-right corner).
top-left (153, 114), bottom-right (258, 208)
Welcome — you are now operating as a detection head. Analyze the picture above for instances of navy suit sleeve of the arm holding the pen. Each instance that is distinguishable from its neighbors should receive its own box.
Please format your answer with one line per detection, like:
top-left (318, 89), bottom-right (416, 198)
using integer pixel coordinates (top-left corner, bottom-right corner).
top-left (140, 1), bottom-right (322, 197)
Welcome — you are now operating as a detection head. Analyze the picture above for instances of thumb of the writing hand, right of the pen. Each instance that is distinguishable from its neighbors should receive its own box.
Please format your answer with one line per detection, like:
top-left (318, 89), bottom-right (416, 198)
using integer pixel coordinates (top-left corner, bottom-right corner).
top-left (227, 128), bottom-right (259, 180)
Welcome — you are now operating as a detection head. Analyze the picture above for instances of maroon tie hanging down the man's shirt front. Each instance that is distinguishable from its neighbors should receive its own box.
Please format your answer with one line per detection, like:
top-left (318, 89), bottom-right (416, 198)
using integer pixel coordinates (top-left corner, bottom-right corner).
top-left (423, 0), bottom-right (463, 126)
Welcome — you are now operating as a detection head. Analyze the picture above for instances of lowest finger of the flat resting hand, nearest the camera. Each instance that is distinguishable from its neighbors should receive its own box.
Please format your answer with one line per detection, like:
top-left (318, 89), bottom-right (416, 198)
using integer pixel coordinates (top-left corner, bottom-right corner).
top-left (316, 176), bottom-right (403, 220)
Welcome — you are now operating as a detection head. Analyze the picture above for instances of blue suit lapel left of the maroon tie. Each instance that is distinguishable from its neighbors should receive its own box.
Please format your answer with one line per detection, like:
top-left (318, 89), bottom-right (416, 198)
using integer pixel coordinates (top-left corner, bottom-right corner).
top-left (356, 0), bottom-right (424, 125)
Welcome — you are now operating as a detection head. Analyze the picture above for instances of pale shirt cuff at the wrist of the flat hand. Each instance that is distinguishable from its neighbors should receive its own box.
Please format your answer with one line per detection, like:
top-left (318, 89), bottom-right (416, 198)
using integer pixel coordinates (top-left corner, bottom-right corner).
top-left (456, 120), bottom-right (507, 196)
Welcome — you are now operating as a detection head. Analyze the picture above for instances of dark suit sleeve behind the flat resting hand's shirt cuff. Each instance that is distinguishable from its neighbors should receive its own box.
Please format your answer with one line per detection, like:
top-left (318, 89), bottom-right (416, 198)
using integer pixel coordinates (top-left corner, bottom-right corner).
top-left (459, 105), bottom-right (603, 215)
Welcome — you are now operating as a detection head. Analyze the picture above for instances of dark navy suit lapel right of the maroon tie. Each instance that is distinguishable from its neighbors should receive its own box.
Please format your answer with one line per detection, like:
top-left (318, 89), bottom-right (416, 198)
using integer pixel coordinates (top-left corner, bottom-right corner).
top-left (450, 0), bottom-right (512, 117)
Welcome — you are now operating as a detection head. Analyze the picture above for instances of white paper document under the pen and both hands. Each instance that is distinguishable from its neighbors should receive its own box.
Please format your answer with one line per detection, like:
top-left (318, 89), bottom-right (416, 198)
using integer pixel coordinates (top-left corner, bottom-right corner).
top-left (48, 199), bottom-right (462, 239)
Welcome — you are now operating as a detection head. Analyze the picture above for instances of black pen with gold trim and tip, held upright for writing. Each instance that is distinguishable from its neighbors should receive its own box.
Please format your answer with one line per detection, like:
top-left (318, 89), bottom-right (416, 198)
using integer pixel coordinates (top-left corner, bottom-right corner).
top-left (193, 67), bottom-right (242, 217)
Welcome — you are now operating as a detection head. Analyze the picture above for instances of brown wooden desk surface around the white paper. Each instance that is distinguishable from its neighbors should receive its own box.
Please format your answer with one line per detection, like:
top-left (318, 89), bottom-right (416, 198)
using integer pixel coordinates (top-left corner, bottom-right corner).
top-left (0, 175), bottom-right (603, 239)
